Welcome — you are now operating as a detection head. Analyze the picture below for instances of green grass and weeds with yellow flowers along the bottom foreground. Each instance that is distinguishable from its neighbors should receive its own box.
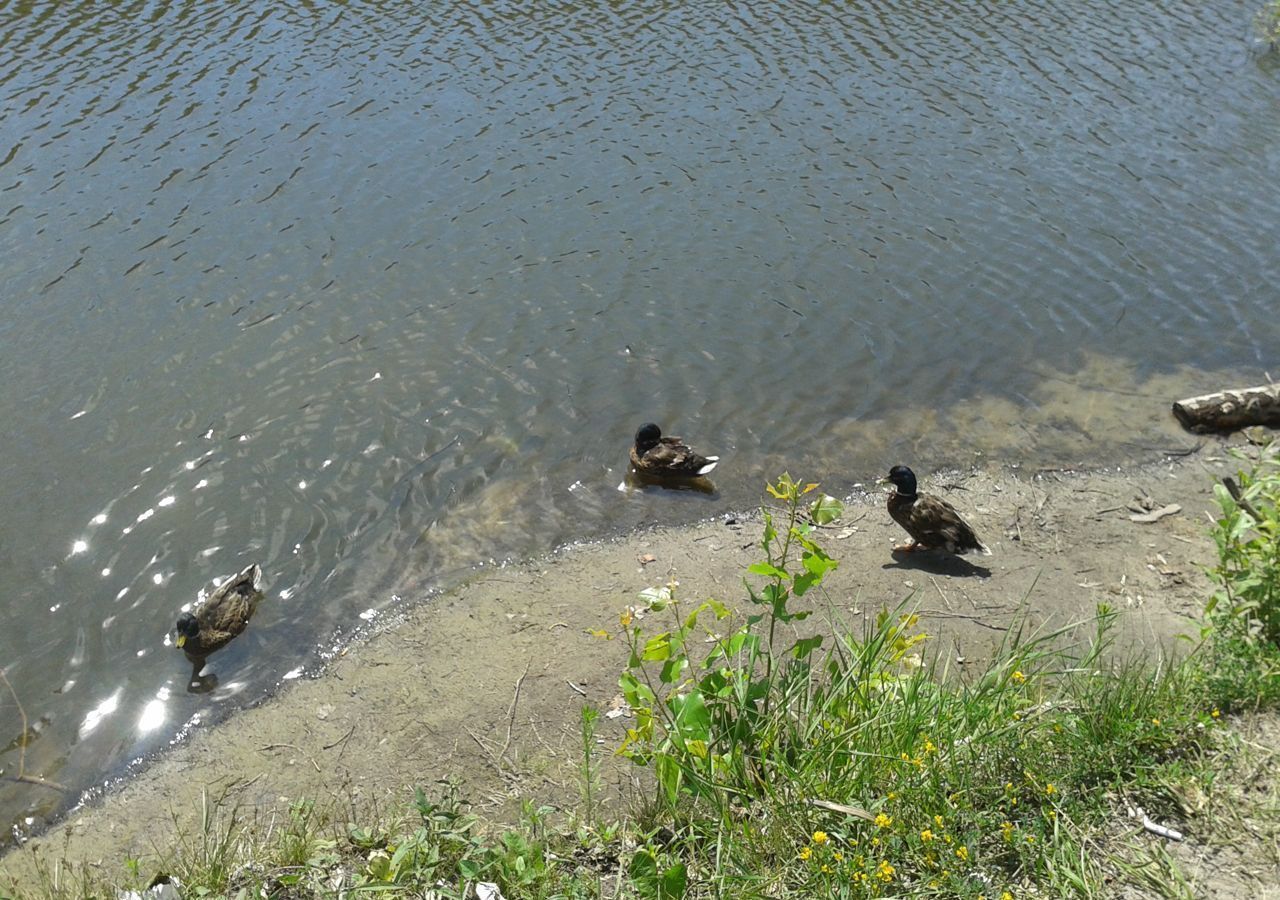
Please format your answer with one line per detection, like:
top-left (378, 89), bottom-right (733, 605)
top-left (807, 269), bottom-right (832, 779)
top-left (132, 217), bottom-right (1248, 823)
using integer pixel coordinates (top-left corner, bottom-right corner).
top-left (0, 448), bottom-right (1280, 900)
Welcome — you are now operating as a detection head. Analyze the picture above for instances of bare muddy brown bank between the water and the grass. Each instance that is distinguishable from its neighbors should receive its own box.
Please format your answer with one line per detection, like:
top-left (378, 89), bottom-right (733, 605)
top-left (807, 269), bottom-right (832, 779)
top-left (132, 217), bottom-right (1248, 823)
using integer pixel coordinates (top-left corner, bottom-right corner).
top-left (3, 442), bottom-right (1236, 878)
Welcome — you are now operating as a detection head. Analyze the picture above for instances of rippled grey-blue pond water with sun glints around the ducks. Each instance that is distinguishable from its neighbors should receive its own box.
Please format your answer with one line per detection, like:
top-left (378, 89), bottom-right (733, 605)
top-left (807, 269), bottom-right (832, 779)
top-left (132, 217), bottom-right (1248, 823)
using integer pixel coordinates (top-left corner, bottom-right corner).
top-left (0, 0), bottom-right (1280, 839)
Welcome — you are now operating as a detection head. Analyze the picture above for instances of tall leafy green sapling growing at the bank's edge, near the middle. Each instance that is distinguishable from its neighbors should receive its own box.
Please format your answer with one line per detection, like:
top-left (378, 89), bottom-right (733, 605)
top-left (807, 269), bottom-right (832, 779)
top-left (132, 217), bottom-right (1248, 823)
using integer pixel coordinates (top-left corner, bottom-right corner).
top-left (620, 475), bottom-right (842, 807)
